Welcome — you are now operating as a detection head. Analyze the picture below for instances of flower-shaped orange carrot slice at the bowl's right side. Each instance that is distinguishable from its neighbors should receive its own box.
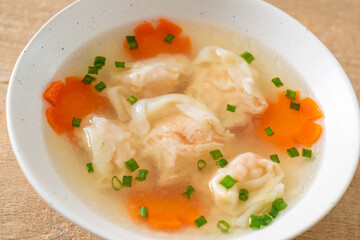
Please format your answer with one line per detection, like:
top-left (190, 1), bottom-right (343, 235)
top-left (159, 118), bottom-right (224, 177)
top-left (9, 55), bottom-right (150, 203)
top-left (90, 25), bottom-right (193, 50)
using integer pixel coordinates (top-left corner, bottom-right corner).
top-left (256, 92), bottom-right (322, 150)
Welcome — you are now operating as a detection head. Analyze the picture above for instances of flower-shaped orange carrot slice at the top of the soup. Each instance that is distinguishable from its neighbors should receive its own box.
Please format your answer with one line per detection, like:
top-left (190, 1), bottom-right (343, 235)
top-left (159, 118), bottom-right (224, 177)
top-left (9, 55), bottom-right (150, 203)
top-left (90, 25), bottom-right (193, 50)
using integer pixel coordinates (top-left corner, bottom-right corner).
top-left (124, 18), bottom-right (191, 59)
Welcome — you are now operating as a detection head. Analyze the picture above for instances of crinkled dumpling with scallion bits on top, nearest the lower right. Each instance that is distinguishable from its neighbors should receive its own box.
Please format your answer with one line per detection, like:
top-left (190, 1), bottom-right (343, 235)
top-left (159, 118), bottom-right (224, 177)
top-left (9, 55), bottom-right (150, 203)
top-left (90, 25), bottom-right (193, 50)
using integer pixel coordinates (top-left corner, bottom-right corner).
top-left (209, 152), bottom-right (284, 227)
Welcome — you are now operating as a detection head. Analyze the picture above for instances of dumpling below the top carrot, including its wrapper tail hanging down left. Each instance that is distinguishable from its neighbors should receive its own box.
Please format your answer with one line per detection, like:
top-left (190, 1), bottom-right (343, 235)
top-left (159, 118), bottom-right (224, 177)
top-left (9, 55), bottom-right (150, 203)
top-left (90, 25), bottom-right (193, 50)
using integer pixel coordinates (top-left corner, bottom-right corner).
top-left (106, 54), bottom-right (193, 121)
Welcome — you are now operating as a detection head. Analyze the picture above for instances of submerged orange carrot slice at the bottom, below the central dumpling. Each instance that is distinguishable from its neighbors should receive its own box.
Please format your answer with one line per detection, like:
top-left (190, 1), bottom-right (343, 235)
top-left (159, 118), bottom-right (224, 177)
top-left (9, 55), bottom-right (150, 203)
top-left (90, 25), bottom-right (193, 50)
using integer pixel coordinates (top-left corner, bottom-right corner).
top-left (127, 187), bottom-right (200, 230)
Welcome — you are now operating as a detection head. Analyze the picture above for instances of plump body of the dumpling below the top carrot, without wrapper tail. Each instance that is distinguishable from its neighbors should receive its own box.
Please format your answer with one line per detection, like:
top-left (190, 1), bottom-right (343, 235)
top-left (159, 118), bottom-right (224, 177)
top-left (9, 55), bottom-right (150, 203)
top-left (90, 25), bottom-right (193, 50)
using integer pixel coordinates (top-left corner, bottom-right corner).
top-left (111, 54), bottom-right (192, 98)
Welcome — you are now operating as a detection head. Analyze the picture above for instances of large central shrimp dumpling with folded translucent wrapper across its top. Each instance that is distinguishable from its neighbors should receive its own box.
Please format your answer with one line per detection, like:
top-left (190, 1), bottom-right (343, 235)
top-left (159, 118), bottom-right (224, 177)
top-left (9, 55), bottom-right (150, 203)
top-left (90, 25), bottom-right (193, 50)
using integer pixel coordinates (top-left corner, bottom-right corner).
top-left (130, 94), bottom-right (231, 184)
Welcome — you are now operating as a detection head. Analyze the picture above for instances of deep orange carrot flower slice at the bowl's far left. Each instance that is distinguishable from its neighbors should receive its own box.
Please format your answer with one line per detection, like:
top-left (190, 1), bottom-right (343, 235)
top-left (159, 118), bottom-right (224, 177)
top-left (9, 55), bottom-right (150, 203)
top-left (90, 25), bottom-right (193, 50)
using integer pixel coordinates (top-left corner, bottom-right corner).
top-left (44, 77), bottom-right (108, 137)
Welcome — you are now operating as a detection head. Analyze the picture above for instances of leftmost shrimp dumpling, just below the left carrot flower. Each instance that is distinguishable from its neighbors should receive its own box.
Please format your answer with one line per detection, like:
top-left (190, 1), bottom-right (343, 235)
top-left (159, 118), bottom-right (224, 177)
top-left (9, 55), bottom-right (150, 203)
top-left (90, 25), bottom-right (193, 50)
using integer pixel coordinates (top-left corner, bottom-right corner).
top-left (80, 117), bottom-right (135, 179)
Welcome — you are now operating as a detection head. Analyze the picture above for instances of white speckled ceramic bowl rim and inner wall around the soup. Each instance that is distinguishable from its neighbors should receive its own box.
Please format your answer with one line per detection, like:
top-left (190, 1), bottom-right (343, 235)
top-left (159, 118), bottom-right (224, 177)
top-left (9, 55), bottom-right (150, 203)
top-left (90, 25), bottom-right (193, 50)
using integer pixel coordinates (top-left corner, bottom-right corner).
top-left (7, 0), bottom-right (360, 239)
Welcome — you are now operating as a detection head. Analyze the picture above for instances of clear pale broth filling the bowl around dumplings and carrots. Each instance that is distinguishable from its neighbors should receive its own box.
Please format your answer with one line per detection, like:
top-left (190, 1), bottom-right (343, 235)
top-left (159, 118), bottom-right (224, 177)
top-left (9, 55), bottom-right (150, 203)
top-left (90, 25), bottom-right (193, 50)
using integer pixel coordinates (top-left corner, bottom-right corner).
top-left (44, 19), bottom-right (322, 239)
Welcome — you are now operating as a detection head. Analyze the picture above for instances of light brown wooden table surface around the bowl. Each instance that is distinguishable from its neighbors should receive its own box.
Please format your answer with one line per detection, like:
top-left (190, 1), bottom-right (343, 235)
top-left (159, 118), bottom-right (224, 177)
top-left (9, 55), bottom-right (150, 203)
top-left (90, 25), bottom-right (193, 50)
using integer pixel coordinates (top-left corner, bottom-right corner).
top-left (0, 0), bottom-right (360, 239)
